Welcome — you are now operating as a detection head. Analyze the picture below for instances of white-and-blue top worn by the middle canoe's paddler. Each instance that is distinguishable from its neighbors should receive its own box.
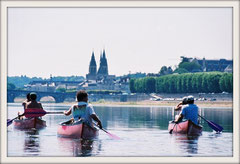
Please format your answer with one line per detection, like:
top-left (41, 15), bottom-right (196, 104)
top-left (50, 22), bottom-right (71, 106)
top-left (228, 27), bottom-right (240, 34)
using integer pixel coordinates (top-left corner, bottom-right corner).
top-left (72, 102), bottom-right (95, 124)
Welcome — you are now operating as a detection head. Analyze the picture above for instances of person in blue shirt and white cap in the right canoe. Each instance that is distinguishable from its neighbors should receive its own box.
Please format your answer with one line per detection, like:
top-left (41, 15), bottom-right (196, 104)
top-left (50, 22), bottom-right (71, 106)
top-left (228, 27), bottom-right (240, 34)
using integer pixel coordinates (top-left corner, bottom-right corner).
top-left (174, 96), bottom-right (198, 125)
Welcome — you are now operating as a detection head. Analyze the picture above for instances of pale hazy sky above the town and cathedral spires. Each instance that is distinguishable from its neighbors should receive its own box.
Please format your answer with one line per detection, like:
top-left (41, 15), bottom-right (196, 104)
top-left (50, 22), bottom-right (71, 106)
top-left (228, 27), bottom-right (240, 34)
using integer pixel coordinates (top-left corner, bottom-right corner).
top-left (8, 8), bottom-right (232, 78)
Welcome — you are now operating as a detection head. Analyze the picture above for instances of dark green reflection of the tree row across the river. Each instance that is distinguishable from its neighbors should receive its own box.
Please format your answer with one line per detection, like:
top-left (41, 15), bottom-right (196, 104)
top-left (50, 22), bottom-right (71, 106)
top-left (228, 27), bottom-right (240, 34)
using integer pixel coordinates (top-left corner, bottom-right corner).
top-left (95, 106), bottom-right (233, 132)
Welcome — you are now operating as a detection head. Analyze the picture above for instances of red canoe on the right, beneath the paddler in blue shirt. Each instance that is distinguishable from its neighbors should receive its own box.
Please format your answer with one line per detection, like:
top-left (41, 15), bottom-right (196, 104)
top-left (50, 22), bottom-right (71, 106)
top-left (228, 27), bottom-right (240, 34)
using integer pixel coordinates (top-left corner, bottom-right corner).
top-left (168, 120), bottom-right (202, 135)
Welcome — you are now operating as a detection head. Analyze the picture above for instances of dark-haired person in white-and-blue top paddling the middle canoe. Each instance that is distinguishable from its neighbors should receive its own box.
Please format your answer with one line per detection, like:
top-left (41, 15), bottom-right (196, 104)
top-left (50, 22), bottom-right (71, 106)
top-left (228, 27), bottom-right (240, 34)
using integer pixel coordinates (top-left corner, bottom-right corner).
top-left (64, 90), bottom-right (102, 129)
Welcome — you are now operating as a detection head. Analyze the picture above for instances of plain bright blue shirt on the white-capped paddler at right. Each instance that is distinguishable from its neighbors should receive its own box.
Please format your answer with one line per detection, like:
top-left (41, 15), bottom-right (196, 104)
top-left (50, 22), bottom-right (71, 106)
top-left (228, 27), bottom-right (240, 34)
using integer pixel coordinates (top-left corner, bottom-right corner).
top-left (181, 104), bottom-right (198, 125)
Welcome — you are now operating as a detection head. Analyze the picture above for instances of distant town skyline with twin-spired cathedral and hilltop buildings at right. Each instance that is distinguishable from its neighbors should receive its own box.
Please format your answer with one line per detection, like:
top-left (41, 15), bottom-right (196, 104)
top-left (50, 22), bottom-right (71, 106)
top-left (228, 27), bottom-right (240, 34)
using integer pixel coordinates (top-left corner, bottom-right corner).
top-left (7, 50), bottom-right (233, 93)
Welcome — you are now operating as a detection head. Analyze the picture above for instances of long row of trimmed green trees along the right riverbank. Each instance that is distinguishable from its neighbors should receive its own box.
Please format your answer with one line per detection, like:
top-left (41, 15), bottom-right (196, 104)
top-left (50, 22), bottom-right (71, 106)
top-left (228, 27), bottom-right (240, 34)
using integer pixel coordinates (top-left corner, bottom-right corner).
top-left (129, 72), bottom-right (233, 93)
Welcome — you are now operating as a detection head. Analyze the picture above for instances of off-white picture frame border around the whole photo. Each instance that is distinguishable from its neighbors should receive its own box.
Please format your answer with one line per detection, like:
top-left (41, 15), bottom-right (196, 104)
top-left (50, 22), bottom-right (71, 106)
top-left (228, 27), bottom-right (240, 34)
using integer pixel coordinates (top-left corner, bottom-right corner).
top-left (0, 0), bottom-right (240, 163)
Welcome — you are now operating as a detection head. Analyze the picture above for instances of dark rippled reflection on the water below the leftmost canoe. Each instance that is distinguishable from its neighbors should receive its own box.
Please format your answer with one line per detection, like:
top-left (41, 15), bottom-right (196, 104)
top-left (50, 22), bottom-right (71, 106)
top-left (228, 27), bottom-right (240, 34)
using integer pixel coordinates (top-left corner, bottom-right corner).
top-left (24, 129), bottom-right (40, 156)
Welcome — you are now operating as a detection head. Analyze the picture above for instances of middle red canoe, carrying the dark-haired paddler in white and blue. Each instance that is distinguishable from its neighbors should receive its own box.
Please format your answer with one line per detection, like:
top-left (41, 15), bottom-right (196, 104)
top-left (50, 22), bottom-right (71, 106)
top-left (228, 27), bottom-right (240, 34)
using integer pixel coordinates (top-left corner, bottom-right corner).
top-left (57, 120), bottom-right (99, 139)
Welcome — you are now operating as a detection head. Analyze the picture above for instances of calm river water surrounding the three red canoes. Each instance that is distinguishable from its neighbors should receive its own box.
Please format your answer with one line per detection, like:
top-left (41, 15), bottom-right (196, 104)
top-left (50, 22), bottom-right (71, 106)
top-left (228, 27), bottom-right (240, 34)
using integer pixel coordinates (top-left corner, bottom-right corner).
top-left (7, 103), bottom-right (233, 157)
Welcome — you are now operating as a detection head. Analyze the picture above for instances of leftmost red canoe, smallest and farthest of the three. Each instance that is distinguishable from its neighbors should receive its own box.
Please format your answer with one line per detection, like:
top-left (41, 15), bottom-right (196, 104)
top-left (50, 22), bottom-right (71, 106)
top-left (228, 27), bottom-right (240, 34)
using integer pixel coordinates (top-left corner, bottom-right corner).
top-left (13, 117), bottom-right (46, 129)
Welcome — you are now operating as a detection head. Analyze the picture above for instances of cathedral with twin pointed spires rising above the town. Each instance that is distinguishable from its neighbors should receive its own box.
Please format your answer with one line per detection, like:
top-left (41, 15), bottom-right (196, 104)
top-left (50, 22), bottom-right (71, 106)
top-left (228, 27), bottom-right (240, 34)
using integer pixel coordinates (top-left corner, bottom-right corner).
top-left (86, 50), bottom-right (112, 81)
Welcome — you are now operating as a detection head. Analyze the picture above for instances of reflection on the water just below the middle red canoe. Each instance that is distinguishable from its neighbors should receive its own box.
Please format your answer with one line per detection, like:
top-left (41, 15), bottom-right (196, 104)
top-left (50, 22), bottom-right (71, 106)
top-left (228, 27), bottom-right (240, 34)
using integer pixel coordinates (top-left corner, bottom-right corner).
top-left (58, 137), bottom-right (101, 157)
